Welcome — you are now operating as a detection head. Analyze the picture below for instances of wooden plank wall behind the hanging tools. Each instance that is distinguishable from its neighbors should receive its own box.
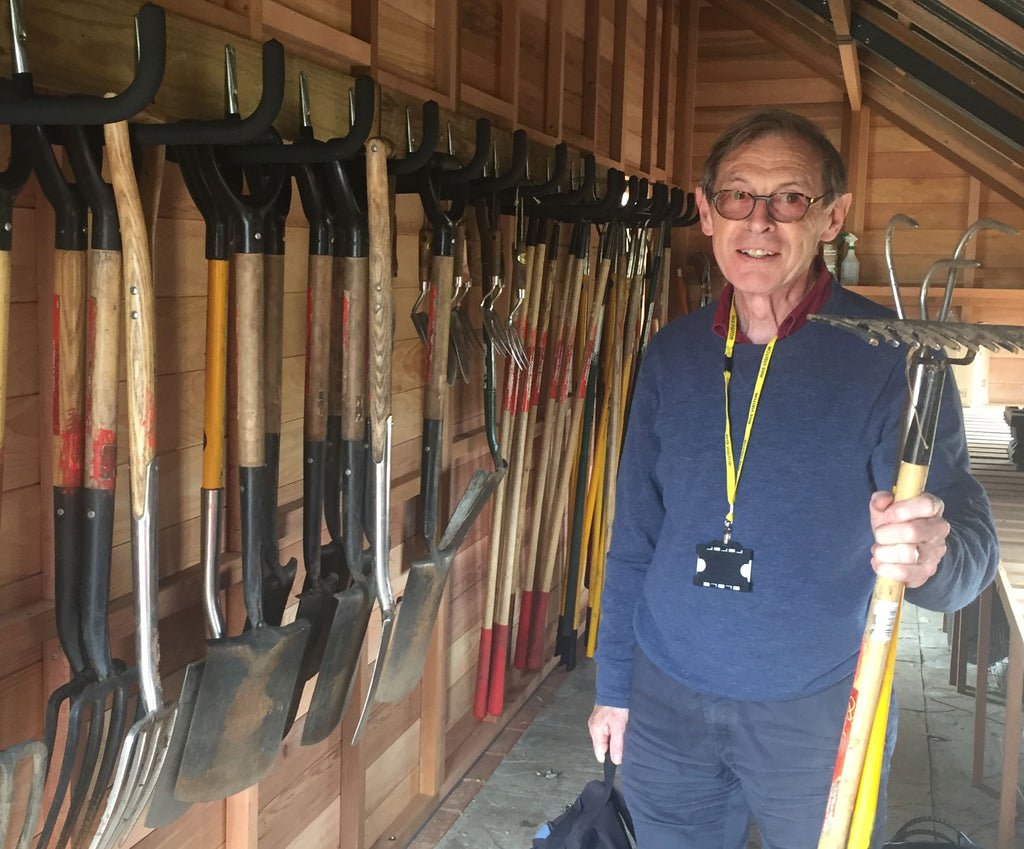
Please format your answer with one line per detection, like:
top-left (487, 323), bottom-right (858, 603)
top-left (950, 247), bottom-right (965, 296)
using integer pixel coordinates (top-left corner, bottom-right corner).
top-left (0, 0), bottom-right (685, 849)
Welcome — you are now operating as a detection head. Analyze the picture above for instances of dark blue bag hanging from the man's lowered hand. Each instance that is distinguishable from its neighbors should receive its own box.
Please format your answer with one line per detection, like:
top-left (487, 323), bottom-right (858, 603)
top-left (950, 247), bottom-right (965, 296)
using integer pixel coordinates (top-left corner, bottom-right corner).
top-left (532, 758), bottom-right (636, 849)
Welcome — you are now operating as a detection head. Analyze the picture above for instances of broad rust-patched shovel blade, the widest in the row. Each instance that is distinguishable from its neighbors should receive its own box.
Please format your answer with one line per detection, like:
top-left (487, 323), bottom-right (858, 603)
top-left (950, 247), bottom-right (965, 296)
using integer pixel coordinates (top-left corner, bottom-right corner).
top-left (174, 622), bottom-right (309, 802)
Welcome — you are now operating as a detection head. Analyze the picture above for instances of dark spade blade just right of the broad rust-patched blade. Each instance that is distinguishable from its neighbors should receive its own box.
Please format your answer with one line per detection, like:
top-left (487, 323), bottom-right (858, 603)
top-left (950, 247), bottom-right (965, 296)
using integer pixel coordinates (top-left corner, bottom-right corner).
top-left (302, 582), bottom-right (374, 746)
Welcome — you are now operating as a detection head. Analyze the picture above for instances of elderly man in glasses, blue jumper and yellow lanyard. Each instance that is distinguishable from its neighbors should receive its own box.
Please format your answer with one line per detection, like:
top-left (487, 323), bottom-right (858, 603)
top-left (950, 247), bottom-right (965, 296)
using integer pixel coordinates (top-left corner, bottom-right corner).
top-left (590, 111), bottom-right (998, 849)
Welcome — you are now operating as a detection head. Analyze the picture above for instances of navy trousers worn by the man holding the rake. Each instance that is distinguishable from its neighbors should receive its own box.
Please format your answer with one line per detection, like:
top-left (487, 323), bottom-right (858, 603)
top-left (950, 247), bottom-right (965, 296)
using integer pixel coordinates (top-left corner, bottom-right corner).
top-left (622, 650), bottom-right (896, 849)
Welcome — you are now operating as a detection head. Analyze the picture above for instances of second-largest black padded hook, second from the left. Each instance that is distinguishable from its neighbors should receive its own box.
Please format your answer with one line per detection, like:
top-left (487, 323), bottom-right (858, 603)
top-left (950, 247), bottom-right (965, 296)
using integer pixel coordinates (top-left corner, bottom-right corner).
top-left (134, 38), bottom-right (285, 145)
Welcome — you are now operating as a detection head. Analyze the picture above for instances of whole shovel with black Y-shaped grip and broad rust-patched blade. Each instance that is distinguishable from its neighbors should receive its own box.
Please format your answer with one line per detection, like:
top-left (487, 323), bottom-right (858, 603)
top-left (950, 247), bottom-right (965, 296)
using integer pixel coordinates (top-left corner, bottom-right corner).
top-left (175, 139), bottom-right (309, 802)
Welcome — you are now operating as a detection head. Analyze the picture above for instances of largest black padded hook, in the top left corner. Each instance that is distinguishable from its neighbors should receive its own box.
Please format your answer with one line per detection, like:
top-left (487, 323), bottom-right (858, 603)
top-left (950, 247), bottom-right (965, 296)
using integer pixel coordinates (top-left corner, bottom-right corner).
top-left (0, 3), bottom-right (166, 126)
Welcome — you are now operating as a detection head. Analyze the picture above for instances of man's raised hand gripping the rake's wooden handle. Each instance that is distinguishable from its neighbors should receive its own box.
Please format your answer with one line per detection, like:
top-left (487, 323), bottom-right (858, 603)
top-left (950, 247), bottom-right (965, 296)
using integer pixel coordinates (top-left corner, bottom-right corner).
top-left (870, 492), bottom-right (949, 588)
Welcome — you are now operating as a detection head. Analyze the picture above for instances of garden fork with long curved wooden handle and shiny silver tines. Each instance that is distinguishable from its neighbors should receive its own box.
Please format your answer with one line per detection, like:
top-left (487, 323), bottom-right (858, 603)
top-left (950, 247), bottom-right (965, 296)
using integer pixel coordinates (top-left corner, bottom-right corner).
top-left (91, 112), bottom-right (177, 849)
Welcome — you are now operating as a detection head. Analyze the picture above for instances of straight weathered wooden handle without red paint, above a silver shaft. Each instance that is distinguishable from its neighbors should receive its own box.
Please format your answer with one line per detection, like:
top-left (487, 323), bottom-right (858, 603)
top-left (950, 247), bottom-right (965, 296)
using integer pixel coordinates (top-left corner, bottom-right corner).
top-left (366, 138), bottom-right (393, 463)
